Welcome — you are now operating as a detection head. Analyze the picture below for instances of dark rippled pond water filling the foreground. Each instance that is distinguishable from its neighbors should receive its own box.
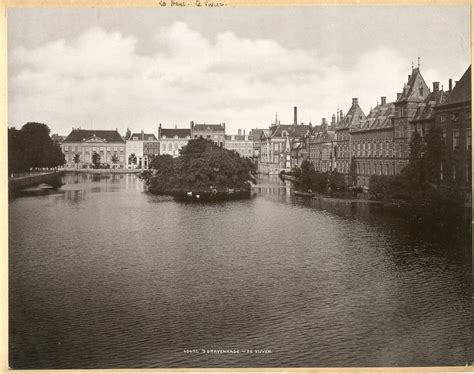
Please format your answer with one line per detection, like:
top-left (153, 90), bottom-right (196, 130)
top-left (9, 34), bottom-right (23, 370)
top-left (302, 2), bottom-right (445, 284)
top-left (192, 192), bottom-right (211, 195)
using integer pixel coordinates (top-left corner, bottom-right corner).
top-left (9, 174), bottom-right (473, 369)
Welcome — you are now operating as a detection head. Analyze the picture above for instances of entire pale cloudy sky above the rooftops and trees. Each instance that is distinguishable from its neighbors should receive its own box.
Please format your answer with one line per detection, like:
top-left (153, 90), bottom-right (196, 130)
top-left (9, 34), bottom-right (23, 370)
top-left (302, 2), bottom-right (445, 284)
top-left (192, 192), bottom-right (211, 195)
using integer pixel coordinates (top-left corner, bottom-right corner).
top-left (8, 6), bottom-right (471, 135)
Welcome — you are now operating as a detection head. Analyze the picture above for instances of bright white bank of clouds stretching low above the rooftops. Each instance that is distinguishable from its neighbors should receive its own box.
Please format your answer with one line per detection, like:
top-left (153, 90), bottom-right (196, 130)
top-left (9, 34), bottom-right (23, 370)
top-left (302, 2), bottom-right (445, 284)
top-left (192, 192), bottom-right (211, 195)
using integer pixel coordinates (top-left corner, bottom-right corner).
top-left (9, 14), bottom-right (467, 134)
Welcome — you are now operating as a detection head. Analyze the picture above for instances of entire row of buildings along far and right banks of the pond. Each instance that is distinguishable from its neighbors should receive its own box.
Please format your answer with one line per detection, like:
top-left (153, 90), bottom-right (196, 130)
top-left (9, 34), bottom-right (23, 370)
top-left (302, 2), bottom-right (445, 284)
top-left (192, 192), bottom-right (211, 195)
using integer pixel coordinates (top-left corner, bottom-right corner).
top-left (61, 67), bottom-right (471, 190)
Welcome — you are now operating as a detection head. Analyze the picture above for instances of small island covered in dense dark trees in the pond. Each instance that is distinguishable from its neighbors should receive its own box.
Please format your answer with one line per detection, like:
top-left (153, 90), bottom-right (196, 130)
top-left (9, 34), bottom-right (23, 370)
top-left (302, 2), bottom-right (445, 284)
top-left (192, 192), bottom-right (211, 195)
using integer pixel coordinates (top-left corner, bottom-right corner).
top-left (140, 138), bottom-right (256, 201)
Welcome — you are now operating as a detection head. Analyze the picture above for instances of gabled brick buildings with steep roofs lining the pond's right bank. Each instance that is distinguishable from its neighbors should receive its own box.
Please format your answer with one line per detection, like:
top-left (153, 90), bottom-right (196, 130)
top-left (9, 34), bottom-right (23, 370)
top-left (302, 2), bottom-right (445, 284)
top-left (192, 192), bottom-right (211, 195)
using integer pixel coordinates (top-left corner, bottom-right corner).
top-left (259, 66), bottom-right (472, 190)
